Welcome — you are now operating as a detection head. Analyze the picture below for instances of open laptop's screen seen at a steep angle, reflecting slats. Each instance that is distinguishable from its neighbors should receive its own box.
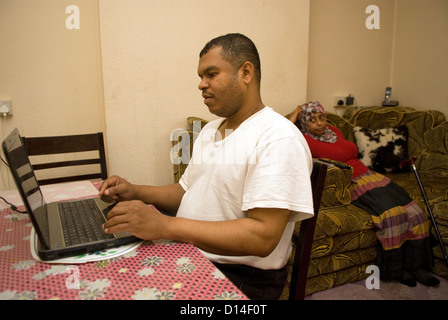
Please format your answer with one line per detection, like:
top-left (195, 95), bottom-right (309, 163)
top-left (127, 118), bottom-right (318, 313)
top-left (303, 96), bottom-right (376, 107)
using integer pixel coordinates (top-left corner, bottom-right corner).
top-left (2, 129), bottom-right (49, 246)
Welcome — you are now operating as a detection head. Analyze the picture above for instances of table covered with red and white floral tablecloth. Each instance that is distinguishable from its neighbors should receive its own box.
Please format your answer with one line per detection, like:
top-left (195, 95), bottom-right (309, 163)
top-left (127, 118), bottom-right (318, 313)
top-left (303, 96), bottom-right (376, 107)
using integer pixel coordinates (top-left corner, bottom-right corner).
top-left (0, 182), bottom-right (247, 300)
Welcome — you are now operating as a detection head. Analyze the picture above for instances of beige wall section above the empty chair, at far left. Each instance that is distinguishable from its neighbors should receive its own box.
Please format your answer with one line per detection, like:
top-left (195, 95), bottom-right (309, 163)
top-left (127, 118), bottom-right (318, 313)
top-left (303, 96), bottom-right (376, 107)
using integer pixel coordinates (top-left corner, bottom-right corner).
top-left (0, 0), bottom-right (105, 189)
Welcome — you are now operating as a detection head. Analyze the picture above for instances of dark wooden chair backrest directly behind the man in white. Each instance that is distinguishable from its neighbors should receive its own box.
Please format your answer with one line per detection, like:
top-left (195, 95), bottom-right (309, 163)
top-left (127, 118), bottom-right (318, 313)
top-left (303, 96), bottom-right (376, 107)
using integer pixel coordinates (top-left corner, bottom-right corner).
top-left (288, 161), bottom-right (328, 300)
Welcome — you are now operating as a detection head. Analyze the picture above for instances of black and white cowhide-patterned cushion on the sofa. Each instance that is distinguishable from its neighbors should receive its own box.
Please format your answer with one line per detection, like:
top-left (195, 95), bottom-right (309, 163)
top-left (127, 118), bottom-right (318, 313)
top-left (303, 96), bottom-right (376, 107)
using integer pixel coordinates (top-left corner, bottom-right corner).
top-left (353, 126), bottom-right (409, 173)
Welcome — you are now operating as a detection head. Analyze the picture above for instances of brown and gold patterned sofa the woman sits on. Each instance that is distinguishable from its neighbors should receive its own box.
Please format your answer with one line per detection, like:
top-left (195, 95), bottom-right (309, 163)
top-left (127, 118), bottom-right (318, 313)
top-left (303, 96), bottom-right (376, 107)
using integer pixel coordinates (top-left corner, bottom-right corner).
top-left (171, 107), bottom-right (448, 295)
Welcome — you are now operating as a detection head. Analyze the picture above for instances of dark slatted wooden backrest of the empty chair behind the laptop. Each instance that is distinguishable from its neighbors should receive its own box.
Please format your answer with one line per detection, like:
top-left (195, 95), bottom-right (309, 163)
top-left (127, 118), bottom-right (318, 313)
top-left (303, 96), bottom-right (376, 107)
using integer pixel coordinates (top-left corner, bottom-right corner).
top-left (23, 132), bottom-right (107, 185)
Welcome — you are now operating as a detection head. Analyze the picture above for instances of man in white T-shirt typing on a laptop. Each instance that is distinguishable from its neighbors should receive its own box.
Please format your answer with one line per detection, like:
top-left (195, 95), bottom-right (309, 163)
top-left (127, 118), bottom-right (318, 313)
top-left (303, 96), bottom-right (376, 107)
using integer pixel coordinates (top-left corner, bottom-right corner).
top-left (99, 34), bottom-right (313, 299)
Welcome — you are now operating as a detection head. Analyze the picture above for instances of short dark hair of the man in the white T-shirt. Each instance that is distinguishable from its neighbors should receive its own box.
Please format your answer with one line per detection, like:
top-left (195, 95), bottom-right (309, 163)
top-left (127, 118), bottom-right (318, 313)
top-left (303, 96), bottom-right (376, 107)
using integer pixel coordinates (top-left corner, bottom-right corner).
top-left (199, 33), bottom-right (261, 84)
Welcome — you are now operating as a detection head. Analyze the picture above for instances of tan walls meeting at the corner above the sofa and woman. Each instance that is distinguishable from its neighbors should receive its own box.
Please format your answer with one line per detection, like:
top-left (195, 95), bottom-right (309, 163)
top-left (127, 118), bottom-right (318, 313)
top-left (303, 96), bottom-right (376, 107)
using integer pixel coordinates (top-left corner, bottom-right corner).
top-left (307, 0), bottom-right (448, 116)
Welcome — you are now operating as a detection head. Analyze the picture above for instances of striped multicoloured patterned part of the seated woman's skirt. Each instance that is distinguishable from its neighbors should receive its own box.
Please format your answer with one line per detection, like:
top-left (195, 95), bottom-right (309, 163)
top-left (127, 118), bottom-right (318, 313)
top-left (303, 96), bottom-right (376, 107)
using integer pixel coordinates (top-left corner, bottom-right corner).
top-left (350, 170), bottom-right (430, 250)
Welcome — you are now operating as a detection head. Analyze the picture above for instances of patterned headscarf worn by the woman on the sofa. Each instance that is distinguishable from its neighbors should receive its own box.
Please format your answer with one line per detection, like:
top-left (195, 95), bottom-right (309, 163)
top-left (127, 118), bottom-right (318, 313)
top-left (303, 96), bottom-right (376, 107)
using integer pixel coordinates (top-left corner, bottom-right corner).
top-left (296, 101), bottom-right (338, 143)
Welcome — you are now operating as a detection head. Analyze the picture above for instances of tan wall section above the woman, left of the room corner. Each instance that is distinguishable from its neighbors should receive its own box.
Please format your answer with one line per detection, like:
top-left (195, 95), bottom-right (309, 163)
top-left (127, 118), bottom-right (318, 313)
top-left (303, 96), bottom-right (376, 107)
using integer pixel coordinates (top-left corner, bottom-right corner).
top-left (307, 0), bottom-right (394, 112)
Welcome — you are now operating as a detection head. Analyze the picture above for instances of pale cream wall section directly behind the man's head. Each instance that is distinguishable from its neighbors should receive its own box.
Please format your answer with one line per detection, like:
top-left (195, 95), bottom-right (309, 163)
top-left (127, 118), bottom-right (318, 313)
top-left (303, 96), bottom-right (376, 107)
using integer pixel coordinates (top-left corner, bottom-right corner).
top-left (99, 0), bottom-right (309, 184)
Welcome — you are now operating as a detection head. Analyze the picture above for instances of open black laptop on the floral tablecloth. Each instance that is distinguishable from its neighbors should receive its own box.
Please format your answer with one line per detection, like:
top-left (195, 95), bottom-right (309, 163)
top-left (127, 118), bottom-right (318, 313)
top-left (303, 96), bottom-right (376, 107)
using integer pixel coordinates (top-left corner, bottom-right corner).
top-left (2, 128), bottom-right (140, 261)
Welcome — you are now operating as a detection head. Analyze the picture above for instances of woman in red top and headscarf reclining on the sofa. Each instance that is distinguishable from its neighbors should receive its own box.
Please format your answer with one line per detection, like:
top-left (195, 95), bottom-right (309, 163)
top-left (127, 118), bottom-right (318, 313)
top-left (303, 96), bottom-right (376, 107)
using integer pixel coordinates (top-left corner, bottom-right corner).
top-left (287, 101), bottom-right (439, 286)
